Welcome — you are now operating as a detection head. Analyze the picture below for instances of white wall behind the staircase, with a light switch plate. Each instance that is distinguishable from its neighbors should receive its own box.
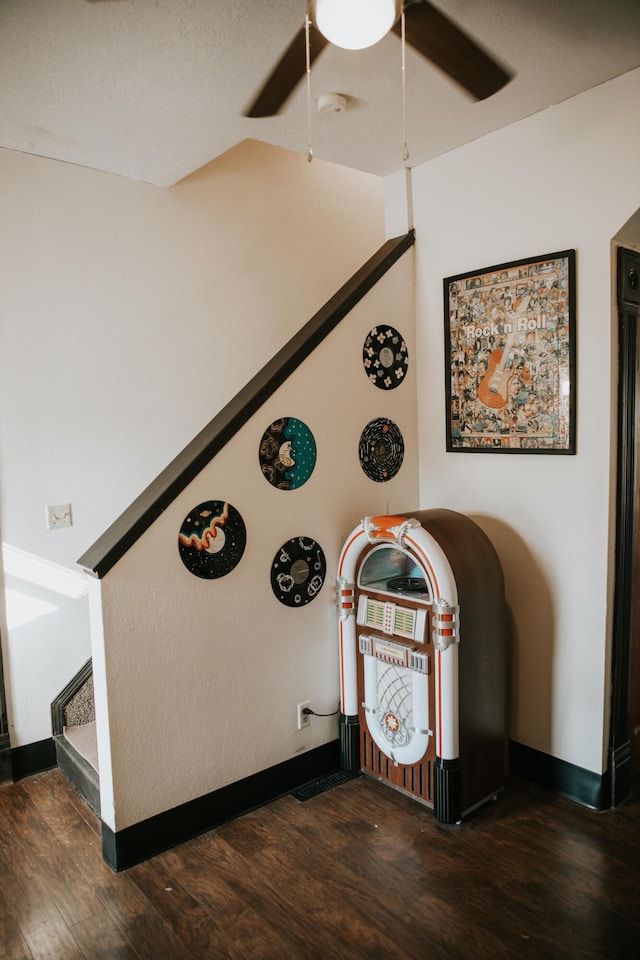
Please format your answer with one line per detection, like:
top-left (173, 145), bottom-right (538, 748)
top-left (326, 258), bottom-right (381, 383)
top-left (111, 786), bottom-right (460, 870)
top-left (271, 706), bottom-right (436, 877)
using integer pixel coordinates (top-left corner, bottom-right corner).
top-left (0, 141), bottom-right (384, 747)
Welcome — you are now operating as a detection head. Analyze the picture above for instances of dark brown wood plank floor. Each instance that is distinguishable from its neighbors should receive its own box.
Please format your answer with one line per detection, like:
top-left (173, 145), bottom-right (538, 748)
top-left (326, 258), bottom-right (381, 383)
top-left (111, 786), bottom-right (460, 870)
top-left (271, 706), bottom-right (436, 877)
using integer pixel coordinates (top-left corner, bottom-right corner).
top-left (0, 770), bottom-right (640, 960)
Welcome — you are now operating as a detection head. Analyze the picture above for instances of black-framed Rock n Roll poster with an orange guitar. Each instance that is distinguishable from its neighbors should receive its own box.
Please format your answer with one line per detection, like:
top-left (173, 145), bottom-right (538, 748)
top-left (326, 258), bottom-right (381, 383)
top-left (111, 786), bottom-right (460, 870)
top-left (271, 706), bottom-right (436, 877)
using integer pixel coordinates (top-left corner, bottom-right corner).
top-left (444, 250), bottom-right (576, 454)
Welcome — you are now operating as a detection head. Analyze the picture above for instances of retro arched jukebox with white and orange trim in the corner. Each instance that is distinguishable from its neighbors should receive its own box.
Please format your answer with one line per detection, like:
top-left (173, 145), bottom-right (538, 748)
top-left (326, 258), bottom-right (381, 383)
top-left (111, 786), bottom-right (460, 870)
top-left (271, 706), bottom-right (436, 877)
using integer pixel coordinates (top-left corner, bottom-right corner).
top-left (338, 510), bottom-right (506, 823)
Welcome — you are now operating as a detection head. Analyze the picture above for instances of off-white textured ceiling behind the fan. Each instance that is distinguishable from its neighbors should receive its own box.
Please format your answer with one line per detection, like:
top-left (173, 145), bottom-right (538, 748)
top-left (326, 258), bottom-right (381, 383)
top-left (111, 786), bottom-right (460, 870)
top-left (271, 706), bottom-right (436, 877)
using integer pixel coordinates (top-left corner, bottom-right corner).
top-left (0, 0), bottom-right (640, 186)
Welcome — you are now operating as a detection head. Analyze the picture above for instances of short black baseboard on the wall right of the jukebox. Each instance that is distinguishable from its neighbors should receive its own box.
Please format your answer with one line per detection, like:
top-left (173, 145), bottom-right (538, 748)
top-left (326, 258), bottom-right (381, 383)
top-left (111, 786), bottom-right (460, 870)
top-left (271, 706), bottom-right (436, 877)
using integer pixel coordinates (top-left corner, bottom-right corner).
top-left (509, 740), bottom-right (611, 810)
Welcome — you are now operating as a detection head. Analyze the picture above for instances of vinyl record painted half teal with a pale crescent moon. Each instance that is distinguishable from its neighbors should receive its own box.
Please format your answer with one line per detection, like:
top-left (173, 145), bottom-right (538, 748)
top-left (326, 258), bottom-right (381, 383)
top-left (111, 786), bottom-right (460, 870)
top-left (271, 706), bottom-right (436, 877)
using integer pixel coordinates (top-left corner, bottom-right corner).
top-left (259, 417), bottom-right (316, 490)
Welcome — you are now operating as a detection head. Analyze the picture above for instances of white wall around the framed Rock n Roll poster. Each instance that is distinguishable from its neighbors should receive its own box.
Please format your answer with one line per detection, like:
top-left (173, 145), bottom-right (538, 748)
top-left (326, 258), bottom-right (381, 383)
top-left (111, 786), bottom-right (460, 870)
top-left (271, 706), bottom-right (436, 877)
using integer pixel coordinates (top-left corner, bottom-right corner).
top-left (412, 65), bottom-right (640, 772)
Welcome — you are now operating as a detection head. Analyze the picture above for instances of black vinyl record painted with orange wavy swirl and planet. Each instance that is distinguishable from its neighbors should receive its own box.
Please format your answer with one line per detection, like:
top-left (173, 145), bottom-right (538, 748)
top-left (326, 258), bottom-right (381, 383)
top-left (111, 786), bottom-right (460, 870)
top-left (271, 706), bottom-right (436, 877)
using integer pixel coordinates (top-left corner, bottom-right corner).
top-left (178, 500), bottom-right (247, 580)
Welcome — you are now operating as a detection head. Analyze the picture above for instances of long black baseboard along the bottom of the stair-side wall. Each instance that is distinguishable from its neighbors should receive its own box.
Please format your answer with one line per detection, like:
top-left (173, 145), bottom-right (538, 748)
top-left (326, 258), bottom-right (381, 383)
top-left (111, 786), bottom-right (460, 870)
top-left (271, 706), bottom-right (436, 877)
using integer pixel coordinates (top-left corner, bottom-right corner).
top-left (102, 740), bottom-right (340, 871)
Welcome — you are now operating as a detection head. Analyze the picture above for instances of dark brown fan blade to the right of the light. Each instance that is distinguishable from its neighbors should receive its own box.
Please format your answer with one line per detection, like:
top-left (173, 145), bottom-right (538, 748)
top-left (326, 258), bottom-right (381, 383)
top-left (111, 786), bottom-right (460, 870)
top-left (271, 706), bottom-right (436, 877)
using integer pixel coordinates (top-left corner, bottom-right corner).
top-left (393, 0), bottom-right (512, 100)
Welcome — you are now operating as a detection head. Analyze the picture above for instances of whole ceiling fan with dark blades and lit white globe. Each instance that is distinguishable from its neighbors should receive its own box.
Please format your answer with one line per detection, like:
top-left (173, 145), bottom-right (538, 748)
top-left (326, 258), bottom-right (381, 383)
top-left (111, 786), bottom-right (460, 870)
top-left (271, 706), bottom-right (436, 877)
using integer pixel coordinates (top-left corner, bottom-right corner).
top-left (244, 0), bottom-right (511, 117)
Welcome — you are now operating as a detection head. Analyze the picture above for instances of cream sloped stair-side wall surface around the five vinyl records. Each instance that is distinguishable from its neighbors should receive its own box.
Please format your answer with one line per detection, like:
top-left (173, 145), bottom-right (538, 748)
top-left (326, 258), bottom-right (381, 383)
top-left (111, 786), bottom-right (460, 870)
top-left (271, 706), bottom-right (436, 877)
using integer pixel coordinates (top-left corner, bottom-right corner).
top-left (94, 252), bottom-right (418, 830)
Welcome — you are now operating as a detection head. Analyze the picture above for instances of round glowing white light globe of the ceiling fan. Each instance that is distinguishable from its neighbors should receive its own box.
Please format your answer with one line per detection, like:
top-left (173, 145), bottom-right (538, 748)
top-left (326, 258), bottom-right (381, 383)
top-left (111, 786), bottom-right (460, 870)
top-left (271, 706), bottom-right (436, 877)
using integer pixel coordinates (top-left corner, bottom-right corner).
top-left (311, 0), bottom-right (402, 50)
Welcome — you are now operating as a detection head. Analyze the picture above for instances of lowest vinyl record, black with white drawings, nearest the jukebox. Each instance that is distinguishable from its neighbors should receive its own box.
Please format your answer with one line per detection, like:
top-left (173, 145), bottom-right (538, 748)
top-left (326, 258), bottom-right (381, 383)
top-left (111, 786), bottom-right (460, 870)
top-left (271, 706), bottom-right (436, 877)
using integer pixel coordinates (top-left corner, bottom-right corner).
top-left (271, 537), bottom-right (327, 607)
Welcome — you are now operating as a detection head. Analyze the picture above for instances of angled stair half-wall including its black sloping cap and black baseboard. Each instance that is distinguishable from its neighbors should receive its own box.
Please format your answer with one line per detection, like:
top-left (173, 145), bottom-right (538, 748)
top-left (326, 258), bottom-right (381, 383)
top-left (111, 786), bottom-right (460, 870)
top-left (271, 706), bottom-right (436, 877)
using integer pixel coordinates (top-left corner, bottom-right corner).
top-left (79, 232), bottom-right (418, 868)
